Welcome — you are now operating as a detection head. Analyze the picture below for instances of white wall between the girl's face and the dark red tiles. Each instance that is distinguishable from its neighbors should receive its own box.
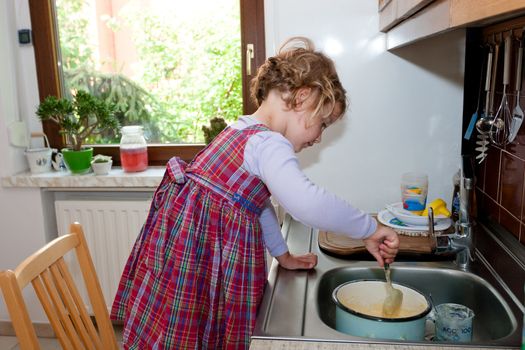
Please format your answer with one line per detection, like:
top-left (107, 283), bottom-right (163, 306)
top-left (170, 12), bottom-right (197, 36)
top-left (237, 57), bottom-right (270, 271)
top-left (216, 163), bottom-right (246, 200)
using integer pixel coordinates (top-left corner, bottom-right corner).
top-left (265, 0), bottom-right (465, 212)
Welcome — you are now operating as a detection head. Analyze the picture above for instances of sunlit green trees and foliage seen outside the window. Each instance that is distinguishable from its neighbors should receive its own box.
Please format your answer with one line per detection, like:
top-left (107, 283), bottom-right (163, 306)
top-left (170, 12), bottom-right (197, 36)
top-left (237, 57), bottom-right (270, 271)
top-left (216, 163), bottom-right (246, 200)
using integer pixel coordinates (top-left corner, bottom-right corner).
top-left (56, 0), bottom-right (242, 143)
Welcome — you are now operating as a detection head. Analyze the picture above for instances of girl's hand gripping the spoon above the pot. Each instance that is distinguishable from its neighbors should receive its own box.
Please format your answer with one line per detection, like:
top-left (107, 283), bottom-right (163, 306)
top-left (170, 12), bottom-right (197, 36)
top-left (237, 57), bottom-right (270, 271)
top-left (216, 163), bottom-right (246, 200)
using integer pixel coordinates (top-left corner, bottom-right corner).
top-left (363, 224), bottom-right (399, 267)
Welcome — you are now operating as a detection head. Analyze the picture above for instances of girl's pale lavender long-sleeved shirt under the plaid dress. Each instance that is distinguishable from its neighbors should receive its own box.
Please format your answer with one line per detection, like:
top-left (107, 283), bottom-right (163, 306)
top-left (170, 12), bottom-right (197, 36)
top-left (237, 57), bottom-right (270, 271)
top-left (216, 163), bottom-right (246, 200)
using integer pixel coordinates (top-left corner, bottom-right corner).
top-left (232, 116), bottom-right (377, 257)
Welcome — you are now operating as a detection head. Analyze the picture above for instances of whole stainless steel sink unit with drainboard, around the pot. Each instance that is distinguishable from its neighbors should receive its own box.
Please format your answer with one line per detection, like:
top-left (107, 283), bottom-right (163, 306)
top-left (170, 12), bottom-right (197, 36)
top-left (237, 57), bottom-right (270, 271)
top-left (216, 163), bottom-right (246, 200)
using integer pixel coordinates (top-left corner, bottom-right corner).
top-left (253, 218), bottom-right (523, 348)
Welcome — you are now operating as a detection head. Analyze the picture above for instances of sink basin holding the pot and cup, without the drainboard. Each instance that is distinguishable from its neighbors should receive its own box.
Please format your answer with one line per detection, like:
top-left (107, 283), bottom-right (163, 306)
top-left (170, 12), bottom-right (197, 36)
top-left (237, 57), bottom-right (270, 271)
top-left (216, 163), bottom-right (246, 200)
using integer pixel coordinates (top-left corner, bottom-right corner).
top-left (316, 266), bottom-right (517, 343)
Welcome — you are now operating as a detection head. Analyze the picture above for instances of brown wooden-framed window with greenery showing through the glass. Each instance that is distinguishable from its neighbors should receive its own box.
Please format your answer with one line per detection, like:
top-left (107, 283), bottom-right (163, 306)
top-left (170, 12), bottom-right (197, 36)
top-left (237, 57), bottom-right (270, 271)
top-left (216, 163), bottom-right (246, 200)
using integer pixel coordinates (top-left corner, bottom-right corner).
top-left (29, 0), bottom-right (265, 165)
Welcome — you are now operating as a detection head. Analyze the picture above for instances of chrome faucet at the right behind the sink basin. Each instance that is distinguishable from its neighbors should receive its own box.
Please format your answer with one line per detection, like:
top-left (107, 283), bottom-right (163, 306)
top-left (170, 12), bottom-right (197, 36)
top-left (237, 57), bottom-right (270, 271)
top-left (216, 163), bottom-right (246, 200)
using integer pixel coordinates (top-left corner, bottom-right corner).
top-left (434, 156), bottom-right (475, 270)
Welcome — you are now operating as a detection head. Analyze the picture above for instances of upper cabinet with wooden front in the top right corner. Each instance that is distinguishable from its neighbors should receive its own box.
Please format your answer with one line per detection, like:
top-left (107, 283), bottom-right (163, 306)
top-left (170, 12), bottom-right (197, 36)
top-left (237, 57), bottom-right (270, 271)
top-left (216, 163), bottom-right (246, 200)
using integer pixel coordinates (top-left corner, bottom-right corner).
top-left (378, 0), bottom-right (525, 50)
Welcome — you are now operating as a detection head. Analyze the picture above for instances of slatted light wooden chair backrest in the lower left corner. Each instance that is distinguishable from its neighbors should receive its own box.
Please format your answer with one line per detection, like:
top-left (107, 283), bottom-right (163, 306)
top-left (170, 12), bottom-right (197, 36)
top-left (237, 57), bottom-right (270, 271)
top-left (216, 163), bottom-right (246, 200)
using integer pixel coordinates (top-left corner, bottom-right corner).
top-left (0, 222), bottom-right (118, 350)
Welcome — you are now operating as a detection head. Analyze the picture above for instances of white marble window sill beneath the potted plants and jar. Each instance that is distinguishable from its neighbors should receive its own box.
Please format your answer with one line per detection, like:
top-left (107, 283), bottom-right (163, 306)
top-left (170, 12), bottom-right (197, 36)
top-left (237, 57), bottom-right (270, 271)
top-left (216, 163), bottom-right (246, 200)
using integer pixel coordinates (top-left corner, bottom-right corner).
top-left (1, 166), bottom-right (166, 190)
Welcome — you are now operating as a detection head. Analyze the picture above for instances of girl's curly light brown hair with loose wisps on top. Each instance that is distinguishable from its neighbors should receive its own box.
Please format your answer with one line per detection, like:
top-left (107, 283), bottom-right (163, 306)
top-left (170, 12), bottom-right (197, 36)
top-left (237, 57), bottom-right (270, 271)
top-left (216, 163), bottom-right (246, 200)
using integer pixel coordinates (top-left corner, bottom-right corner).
top-left (250, 37), bottom-right (347, 120)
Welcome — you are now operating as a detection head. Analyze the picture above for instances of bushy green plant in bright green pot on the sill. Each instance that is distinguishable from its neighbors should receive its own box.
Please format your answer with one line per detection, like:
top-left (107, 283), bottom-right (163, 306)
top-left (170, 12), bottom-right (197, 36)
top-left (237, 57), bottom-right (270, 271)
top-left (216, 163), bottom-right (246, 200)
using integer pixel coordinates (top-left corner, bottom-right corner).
top-left (36, 90), bottom-right (119, 174)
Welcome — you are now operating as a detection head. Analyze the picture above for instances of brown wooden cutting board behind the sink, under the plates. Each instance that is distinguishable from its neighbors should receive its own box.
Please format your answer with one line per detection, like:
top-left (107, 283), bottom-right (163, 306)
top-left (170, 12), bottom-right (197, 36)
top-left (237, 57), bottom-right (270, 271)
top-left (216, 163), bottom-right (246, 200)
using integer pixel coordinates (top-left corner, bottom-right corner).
top-left (319, 231), bottom-right (435, 255)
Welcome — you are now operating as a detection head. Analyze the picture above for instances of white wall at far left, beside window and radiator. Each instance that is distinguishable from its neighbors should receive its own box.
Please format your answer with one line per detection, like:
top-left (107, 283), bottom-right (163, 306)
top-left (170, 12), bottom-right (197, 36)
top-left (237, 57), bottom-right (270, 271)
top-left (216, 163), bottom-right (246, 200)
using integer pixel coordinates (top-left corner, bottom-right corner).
top-left (0, 0), bottom-right (45, 322)
